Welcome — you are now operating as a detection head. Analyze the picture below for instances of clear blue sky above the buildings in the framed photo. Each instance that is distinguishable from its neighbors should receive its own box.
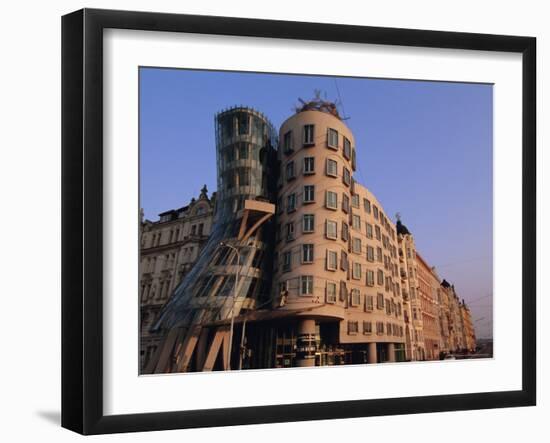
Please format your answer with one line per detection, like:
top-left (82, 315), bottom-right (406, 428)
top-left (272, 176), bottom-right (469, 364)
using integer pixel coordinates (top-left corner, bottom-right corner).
top-left (140, 68), bottom-right (493, 337)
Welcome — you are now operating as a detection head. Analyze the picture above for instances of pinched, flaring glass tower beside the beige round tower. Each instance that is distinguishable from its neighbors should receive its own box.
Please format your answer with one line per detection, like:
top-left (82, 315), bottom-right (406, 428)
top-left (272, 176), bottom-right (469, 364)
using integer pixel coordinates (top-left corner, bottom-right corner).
top-left (153, 107), bottom-right (277, 330)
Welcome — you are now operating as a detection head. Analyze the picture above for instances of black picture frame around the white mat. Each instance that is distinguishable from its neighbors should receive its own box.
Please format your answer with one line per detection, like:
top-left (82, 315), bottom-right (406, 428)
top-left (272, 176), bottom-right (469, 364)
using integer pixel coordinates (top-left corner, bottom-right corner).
top-left (62, 9), bottom-right (536, 434)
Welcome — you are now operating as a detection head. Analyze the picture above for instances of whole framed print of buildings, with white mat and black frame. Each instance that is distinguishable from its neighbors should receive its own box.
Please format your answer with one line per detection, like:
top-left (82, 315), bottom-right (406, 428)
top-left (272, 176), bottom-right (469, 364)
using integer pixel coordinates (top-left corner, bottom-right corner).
top-left (62, 9), bottom-right (536, 434)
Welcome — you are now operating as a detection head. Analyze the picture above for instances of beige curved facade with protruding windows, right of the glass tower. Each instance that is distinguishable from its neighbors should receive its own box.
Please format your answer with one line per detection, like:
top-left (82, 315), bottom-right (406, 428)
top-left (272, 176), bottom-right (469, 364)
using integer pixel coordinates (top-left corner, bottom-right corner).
top-left (273, 110), bottom-right (405, 343)
